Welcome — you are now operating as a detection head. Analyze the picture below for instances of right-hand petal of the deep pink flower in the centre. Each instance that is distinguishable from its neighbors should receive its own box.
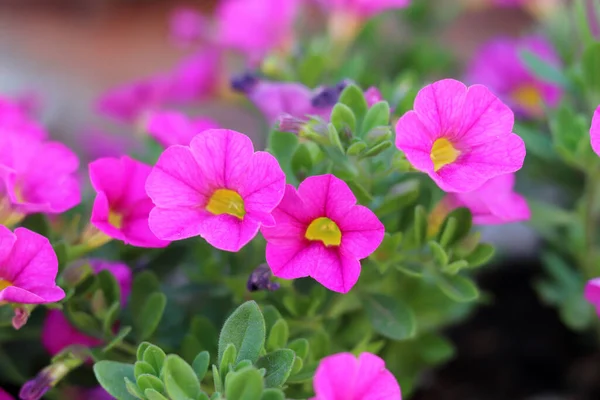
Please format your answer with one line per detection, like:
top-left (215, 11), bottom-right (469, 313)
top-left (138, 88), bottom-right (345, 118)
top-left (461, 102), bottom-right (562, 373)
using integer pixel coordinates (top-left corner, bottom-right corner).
top-left (338, 206), bottom-right (385, 260)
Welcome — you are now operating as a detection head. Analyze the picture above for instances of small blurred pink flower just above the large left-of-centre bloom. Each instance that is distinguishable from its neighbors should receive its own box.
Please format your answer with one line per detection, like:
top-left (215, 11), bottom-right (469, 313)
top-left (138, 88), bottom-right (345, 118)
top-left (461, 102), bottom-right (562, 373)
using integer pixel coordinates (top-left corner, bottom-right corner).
top-left (148, 111), bottom-right (219, 147)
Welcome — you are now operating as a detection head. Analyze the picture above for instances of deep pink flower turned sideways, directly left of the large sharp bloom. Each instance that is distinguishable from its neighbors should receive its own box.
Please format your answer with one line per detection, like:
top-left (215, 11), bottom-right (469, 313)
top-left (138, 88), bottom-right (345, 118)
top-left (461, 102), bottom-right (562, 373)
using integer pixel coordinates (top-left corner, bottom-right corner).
top-left (89, 156), bottom-right (169, 247)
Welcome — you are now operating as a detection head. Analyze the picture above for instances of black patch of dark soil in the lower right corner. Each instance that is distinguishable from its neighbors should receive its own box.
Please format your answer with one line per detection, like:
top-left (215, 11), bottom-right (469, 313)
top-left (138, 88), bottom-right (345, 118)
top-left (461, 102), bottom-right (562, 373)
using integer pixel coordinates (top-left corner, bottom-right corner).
top-left (413, 262), bottom-right (600, 400)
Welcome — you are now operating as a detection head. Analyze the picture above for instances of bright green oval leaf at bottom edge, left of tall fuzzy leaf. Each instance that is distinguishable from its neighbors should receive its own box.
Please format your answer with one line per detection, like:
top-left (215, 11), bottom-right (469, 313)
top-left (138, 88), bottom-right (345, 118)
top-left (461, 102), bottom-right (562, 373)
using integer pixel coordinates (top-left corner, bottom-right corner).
top-left (162, 354), bottom-right (201, 400)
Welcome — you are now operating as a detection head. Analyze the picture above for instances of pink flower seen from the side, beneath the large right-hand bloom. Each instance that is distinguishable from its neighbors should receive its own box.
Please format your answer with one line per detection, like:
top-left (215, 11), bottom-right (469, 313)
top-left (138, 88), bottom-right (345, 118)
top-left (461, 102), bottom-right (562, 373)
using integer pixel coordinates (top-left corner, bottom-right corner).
top-left (442, 174), bottom-right (531, 225)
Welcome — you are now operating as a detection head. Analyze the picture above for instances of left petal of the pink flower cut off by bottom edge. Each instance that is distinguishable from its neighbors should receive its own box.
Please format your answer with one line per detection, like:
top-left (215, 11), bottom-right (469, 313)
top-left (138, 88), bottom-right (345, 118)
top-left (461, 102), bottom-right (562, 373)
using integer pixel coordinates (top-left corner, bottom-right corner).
top-left (313, 353), bottom-right (359, 400)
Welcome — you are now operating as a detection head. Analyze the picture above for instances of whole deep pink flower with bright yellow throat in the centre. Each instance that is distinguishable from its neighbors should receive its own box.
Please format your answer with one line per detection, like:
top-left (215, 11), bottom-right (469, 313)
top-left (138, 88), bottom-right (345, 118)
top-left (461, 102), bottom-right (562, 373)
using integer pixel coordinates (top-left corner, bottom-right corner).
top-left (261, 175), bottom-right (385, 293)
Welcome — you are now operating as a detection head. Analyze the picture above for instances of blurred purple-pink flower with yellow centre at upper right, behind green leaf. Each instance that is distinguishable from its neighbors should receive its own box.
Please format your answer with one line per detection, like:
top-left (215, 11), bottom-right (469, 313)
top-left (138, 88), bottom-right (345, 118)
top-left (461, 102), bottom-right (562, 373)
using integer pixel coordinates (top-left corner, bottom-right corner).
top-left (467, 36), bottom-right (562, 117)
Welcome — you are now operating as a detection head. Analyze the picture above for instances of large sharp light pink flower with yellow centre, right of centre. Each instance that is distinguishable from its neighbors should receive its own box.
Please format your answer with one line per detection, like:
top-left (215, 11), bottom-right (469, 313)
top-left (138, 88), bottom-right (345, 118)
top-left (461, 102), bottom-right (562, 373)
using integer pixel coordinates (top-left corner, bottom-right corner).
top-left (396, 79), bottom-right (525, 192)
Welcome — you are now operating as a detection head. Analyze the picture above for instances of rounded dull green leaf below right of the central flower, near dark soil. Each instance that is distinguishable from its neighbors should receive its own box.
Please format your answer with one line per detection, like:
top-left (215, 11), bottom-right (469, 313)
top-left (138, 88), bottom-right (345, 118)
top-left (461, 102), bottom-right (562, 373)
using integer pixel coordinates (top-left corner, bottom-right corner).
top-left (364, 294), bottom-right (417, 340)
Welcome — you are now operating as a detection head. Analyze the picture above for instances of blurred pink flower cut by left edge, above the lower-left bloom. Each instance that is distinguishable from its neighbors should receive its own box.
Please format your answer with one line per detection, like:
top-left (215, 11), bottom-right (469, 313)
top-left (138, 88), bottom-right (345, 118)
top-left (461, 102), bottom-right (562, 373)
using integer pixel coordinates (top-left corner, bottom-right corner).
top-left (0, 135), bottom-right (81, 225)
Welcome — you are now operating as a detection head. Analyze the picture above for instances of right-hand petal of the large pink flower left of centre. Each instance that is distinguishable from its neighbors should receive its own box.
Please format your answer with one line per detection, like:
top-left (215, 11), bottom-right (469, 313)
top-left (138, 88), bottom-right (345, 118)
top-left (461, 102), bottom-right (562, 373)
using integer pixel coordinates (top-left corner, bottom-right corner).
top-left (239, 151), bottom-right (285, 213)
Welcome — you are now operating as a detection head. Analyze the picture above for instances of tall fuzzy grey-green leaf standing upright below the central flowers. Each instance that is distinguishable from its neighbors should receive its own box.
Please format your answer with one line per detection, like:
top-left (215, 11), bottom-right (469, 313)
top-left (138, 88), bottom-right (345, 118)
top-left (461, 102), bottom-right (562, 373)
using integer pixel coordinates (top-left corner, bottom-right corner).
top-left (218, 301), bottom-right (265, 362)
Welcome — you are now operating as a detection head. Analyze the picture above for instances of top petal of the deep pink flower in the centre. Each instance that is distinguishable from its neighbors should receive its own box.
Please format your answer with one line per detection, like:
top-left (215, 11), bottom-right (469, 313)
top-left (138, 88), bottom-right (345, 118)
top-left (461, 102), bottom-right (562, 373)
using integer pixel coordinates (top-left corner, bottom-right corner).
top-left (298, 174), bottom-right (356, 221)
